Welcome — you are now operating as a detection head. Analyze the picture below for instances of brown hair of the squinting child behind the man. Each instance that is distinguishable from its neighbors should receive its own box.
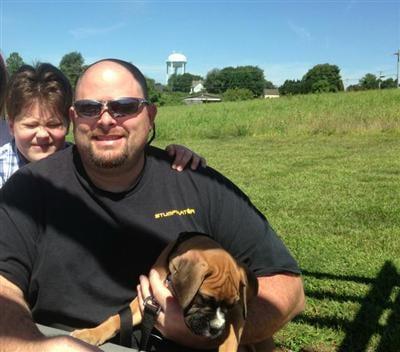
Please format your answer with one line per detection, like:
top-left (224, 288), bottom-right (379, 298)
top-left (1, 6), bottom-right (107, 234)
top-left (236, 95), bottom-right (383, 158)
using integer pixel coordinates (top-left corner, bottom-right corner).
top-left (6, 63), bottom-right (72, 126)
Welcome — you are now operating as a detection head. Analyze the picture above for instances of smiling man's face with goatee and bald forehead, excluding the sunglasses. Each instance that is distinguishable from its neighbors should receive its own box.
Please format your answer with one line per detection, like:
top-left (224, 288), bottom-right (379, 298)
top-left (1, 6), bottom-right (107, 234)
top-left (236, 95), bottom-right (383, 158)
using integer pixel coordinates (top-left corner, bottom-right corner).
top-left (71, 62), bottom-right (155, 169)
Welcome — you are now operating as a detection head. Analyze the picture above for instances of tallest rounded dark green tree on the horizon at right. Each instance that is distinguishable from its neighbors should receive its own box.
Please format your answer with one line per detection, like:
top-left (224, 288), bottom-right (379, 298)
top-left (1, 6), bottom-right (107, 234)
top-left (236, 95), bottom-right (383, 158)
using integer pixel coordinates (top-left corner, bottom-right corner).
top-left (302, 64), bottom-right (344, 93)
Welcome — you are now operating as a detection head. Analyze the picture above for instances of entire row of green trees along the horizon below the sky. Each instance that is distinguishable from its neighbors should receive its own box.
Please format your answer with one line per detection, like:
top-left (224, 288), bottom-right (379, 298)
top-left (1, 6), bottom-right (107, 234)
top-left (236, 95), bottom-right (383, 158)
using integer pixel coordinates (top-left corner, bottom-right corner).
top-left (6, 51), bottom-right (397, 105)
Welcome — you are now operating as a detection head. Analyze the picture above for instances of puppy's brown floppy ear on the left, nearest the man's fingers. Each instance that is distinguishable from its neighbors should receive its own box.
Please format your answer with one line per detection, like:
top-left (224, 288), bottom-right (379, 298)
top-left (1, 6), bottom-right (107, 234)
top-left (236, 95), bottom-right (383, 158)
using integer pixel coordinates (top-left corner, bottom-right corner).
top-left (170, 253), bottom-right (208, 309)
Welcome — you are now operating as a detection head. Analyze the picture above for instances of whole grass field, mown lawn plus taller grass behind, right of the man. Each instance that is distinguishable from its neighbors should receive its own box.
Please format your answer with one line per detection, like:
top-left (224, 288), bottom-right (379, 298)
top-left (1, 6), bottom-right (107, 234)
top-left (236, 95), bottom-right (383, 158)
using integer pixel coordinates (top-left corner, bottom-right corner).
top-left (152, 89), bottom-right (400, 352)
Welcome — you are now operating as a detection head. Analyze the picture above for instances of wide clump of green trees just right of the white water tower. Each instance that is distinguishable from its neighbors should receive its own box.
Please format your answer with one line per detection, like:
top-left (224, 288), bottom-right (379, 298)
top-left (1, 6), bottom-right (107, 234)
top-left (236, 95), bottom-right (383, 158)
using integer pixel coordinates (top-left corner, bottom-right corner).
top-left (204, 66), bottom-right (265, 96)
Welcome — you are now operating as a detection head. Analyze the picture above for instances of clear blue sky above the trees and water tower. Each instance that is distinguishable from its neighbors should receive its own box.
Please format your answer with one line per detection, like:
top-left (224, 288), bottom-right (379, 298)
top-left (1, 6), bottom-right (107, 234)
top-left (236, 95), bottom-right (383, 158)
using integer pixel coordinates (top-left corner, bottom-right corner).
top-left (0, 0), bottom-right (400, 85)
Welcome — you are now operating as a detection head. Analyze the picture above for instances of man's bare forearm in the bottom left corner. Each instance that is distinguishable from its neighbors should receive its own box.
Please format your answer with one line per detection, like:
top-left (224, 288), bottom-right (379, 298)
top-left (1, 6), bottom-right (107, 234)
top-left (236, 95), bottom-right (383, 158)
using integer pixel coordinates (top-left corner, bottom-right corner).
top-left (0, 276), bottom-right (101, 352)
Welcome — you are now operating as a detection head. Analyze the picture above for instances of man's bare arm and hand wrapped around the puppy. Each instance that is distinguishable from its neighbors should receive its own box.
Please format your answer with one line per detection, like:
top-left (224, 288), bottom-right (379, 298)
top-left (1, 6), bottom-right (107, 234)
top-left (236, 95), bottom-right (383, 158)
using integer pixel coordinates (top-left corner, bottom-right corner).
top-left (138, 270), bottom-right (305, 348)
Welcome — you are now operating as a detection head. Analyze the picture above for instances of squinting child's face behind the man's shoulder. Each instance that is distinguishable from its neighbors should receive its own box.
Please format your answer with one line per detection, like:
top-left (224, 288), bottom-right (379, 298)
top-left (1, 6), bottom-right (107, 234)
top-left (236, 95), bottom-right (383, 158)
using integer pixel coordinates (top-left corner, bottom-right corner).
top-left (10, 102), bottom-right (67, 161)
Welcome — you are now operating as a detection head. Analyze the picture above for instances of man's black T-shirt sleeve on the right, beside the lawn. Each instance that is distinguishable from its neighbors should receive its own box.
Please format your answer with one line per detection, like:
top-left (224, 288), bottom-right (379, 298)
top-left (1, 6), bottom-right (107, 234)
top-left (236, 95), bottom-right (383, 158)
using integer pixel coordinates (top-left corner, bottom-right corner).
top-left (203, 168), bottom-right (300, 276)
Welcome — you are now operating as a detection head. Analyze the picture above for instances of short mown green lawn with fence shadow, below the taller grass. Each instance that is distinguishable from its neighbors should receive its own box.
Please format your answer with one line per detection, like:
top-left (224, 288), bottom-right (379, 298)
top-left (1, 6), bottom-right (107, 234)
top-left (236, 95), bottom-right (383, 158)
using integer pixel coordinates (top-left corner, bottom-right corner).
top-left (154, 133), bottom-right (400, 351)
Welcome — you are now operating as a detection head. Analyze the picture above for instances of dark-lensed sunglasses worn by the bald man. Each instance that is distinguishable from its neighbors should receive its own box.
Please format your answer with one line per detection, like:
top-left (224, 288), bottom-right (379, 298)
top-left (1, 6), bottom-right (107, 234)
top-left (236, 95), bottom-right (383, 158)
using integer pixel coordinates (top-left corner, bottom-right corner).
top-left (74, 97), bottom-right (150, 119)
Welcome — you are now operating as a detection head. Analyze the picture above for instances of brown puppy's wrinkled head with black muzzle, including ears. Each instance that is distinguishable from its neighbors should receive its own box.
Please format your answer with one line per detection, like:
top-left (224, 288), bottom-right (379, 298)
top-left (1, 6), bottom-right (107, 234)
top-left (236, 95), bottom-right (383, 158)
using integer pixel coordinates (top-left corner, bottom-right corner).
top-left (171, 250), bottom-right (247, 338)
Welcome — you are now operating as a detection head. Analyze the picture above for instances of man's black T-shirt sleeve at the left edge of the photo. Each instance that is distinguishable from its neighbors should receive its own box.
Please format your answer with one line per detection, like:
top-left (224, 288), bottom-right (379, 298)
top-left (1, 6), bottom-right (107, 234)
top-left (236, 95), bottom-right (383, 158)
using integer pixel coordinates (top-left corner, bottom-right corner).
top-left (0, 169), bottom-right (40, 294)
